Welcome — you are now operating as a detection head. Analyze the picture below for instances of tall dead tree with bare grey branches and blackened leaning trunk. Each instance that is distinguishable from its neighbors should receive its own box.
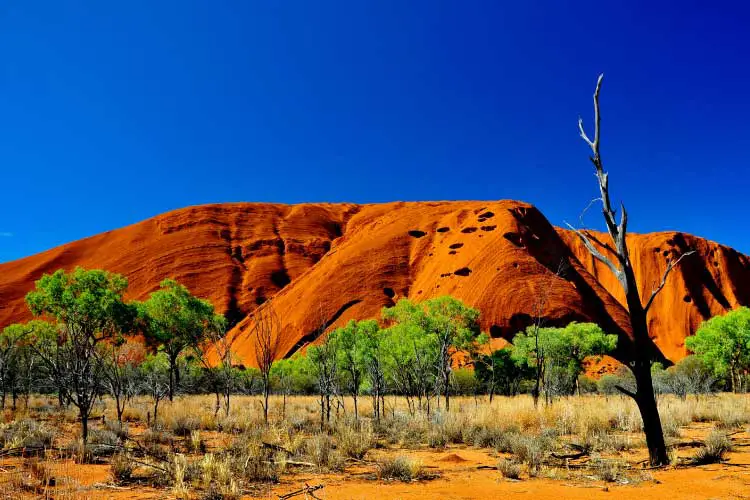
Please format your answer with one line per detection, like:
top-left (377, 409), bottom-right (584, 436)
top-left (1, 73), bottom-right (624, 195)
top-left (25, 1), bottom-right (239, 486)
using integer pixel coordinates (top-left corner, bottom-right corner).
top-left (568, 75), bottom-right (694, 466)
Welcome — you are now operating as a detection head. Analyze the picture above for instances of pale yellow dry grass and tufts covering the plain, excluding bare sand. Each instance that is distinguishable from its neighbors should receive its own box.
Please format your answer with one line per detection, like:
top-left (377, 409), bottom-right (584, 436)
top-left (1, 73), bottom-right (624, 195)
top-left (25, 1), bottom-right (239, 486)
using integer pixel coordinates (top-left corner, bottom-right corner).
top-left (0, 394), bottom-right (750, 499)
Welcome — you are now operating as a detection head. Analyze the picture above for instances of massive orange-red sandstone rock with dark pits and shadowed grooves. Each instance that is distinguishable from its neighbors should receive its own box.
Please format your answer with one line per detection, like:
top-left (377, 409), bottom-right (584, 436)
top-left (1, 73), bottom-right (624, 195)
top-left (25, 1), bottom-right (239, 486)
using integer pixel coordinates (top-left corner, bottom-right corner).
top-left (0, 201), bottom-right (750, 365)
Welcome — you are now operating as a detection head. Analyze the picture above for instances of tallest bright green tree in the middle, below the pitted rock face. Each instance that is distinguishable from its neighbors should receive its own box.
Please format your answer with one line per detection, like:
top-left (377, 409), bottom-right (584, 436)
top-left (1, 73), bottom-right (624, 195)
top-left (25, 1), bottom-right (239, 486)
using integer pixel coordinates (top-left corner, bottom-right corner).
top-left (383, 296), bottom-right (480, 411)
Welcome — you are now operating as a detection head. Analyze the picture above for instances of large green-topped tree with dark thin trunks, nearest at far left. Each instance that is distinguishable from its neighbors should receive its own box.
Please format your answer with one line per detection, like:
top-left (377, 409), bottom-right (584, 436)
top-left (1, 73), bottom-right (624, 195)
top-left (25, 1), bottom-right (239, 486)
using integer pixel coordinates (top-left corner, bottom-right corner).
top-left (26, 267), bottom-right (132, 450)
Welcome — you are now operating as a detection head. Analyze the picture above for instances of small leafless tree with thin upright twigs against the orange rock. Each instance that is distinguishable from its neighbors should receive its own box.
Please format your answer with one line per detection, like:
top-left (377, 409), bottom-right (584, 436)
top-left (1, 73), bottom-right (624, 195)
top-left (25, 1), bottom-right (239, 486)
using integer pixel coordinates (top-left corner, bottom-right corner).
top-left (250, 300), bottom-right (281, 424)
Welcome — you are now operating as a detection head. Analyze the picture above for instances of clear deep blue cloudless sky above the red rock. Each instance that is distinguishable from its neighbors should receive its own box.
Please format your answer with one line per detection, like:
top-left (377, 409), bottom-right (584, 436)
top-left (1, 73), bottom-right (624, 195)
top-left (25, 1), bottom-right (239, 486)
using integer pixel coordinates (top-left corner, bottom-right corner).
top-left (0, 0), bottom-right (750, 261)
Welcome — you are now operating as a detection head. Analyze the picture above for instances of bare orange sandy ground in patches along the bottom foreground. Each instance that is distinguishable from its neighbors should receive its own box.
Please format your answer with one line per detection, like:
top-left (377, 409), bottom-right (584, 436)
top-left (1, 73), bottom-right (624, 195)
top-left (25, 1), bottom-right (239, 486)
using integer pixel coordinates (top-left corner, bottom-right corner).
top-left (0, 424), bottom-right (750, 500)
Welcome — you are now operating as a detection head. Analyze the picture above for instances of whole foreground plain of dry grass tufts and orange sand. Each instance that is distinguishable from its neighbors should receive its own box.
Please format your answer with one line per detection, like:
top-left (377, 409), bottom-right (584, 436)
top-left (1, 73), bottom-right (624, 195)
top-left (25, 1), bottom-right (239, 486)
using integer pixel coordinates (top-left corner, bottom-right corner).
top-left (0, 394), bottom-right (750, 499)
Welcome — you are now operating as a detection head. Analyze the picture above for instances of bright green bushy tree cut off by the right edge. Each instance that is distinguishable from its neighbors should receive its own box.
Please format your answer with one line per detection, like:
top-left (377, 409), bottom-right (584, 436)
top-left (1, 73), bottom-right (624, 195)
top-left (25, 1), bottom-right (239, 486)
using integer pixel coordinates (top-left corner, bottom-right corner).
top-left (685, 307), bottom-right (750, 392)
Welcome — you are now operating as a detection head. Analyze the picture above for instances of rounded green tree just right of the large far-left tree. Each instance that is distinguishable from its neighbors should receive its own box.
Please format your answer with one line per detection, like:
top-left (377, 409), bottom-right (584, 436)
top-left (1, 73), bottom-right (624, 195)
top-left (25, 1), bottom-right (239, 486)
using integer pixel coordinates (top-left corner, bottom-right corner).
top-left (137, 279), bottom-right (226, 401)
